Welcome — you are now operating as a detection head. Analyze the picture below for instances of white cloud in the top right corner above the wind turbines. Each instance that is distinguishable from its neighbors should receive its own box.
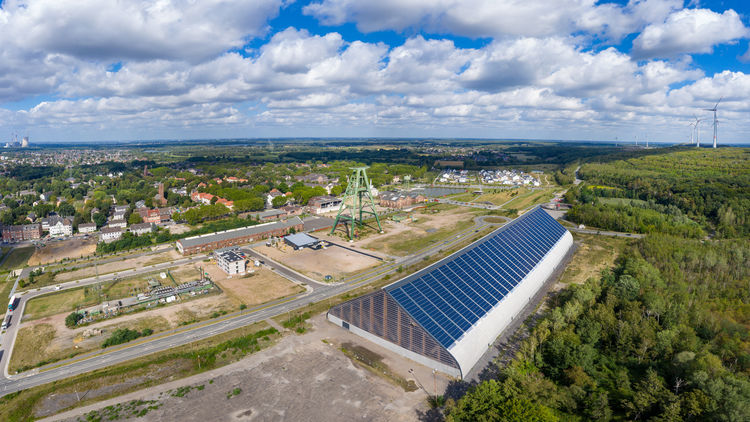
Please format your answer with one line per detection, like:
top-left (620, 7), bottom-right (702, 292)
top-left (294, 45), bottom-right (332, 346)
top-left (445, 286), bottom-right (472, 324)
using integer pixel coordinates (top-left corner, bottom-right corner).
top-left (632, 9), bottom-right (750, 59)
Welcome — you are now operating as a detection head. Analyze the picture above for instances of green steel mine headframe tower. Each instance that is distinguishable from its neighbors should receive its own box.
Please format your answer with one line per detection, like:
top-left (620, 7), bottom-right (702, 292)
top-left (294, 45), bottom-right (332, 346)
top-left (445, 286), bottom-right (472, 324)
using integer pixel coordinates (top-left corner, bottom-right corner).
top-left (331, 167), bottom-right (383, 242)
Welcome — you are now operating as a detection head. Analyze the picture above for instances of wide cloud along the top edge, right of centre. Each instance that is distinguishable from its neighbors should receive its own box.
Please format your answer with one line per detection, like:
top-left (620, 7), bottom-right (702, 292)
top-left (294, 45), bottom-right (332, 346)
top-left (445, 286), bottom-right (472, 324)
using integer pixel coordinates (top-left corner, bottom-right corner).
top-left (304, 0), bottom-right (682, 38)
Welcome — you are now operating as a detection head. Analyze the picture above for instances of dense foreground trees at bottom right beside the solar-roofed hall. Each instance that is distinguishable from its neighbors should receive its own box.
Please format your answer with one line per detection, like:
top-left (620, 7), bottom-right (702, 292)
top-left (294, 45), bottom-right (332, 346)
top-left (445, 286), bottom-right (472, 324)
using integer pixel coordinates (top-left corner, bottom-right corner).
top-left (446, 235), bottom-right (750, 421)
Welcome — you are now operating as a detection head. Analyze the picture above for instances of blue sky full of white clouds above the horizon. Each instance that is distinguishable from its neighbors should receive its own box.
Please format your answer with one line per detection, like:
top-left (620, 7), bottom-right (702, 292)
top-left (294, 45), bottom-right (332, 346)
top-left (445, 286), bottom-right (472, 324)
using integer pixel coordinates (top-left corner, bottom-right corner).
top-left (0, 0), bottom-right (750, 143)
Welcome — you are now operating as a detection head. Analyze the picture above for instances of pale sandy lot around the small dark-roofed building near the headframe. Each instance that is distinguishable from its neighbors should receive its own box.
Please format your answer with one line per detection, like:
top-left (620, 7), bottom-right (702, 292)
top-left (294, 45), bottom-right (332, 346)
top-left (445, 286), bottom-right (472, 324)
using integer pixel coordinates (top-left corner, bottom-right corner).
top-left (255, 239), bottom-right (381, 281)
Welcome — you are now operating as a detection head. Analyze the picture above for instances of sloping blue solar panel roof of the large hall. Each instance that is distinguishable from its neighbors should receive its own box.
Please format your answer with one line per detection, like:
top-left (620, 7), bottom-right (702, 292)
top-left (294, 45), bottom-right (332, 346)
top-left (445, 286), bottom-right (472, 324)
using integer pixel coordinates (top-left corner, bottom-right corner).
top-left (385, 207), bottom-right (566, 349)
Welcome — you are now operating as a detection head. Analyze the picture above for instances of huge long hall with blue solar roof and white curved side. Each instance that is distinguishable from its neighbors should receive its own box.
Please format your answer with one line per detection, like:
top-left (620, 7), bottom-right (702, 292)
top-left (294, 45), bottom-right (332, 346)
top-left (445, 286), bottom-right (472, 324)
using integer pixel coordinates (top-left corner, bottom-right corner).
top-left (328, 207), bottom-right (573, 377)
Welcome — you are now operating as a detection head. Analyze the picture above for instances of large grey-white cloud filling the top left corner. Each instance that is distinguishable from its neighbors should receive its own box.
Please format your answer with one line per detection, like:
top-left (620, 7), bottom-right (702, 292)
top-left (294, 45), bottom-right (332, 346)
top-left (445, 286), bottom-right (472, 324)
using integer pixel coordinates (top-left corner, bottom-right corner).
top-left (0, 0), bottom-right (281, 61)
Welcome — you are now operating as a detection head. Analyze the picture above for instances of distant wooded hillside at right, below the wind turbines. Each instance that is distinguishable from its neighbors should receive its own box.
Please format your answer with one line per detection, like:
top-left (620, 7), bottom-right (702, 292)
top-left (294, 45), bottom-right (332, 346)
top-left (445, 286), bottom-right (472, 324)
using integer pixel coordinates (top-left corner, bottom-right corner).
top-left (566, 148), bottom-right (750, 238)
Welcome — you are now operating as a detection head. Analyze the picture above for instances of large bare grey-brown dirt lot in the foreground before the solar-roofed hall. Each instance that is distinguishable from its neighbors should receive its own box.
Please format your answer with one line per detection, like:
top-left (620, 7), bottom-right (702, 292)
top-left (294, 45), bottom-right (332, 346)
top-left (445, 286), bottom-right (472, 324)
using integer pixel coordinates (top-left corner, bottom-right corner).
top-left (49, 315), bottom-right (448, 421)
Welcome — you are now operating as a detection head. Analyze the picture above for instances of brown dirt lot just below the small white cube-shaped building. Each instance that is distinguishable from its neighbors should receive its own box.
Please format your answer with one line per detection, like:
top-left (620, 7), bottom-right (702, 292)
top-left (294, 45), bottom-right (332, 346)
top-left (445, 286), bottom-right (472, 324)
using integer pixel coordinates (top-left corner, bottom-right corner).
top-left (209, 268), bottom-right (305, 305)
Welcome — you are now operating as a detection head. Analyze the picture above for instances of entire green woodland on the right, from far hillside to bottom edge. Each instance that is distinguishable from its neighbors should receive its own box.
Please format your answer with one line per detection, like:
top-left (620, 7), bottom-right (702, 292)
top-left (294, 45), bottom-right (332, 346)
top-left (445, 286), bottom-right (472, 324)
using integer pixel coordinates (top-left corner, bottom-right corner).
top-left (443, 148), bottom-right (750, 421)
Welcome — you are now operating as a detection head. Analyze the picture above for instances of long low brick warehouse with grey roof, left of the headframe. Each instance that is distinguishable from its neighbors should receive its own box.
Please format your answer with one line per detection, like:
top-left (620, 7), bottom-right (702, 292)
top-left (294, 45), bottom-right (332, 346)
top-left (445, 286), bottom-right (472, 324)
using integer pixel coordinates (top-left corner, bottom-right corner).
top-left (177, 217), bottom-right (304, 255)
